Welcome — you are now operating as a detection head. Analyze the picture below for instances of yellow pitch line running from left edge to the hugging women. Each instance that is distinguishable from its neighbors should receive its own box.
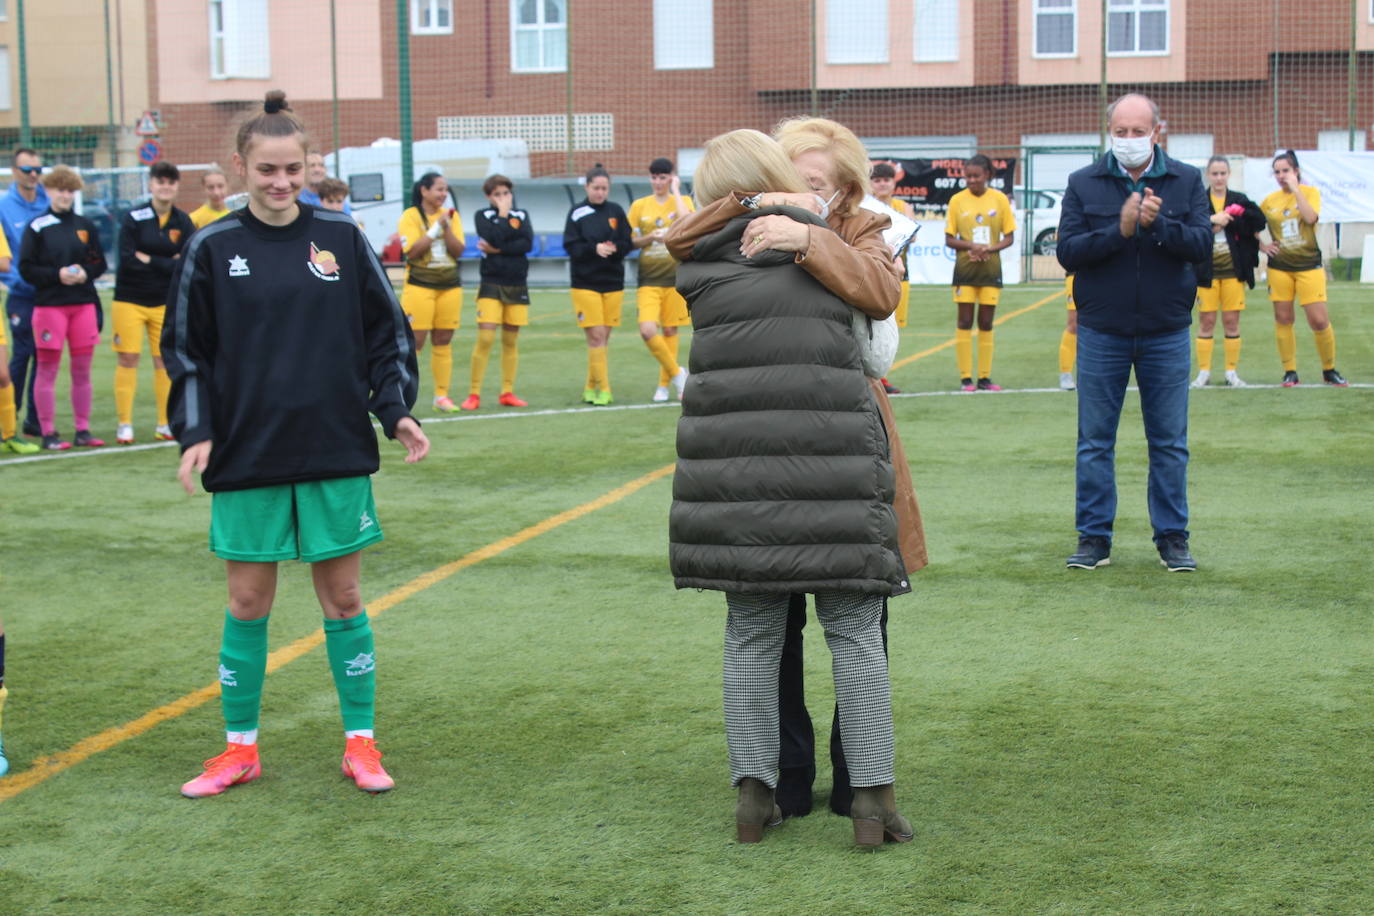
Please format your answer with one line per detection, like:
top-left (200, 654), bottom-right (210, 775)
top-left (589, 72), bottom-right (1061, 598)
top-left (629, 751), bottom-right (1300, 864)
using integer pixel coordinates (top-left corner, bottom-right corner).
top-left (0, 464), bottom-right (673, 802)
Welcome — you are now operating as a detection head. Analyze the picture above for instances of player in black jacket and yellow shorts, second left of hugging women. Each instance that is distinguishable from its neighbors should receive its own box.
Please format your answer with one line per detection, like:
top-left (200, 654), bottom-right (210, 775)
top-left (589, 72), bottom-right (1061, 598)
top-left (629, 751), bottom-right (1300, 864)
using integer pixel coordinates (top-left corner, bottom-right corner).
top-left (563, 162), bottom-right (633, 407)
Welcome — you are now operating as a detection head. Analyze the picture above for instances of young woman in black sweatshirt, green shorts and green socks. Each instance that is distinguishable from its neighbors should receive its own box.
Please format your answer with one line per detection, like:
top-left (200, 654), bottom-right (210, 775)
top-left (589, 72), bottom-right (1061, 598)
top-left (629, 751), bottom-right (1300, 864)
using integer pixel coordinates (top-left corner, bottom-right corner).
top-left (162, 92), bottom-right (429, 798)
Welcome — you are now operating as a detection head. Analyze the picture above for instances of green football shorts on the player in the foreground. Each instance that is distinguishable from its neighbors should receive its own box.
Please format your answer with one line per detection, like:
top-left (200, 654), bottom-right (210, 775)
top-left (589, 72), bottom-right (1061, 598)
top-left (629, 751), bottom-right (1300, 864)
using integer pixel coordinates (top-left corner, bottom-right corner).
top-left (210, 477), bottom-right (382, 563)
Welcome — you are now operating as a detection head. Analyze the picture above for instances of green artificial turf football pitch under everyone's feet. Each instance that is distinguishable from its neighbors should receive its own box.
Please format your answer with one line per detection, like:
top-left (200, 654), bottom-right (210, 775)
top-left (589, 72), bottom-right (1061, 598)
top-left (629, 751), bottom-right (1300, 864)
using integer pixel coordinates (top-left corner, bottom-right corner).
top-left (0, 284), bottom-right (1374, 915)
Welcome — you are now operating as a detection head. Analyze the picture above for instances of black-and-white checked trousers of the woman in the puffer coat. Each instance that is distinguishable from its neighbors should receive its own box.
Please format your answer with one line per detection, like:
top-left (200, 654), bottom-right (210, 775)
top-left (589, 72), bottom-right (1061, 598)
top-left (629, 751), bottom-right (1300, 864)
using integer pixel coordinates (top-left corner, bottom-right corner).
top-left (724, 592), bottom-right (894, 788)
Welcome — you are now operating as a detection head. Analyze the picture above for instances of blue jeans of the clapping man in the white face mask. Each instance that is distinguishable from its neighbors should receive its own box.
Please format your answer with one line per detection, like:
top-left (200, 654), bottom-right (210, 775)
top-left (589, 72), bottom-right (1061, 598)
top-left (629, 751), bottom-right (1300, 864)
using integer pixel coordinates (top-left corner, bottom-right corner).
top-left (1076, 324), bottom-right (1193, 541)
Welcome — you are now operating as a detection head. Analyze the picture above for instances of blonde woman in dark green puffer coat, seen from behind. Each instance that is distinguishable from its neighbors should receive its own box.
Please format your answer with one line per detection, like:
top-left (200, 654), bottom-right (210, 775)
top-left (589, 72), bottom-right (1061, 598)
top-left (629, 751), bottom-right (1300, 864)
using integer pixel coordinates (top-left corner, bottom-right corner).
top-left (669, 130), bottom-right (911, 846)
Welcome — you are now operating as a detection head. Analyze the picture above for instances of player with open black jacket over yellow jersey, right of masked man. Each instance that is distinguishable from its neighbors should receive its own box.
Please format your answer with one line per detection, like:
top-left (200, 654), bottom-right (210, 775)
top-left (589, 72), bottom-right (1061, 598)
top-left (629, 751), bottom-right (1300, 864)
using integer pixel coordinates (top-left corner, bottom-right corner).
top-left (1193, 155), bottom-right (1264, 389)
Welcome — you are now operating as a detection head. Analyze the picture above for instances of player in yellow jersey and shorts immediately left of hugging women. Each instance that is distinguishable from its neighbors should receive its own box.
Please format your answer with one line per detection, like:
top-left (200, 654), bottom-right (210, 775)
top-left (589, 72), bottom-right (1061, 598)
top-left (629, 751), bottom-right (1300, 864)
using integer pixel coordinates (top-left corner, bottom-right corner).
top-left (629, 157), bottom-right (695, 401)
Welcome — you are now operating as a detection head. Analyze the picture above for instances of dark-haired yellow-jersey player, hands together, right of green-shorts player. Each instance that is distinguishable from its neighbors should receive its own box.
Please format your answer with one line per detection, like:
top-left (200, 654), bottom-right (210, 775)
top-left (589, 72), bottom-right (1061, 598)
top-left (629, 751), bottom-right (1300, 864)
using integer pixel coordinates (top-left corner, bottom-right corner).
top-left (396, 172), bottom-right (467, 413)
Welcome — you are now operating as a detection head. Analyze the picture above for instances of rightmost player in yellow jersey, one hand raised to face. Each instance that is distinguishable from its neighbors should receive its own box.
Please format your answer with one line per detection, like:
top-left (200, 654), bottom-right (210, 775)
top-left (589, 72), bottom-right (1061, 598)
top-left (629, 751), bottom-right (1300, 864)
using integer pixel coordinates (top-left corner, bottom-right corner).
top-left (1260, 150), bottom-right (1347, 389)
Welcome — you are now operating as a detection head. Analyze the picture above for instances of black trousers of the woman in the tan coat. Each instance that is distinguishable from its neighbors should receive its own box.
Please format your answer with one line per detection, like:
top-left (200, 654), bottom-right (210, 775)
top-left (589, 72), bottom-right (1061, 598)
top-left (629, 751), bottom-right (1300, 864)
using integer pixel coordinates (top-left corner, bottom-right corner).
top-left (778, 595), bottom-right (888, 794)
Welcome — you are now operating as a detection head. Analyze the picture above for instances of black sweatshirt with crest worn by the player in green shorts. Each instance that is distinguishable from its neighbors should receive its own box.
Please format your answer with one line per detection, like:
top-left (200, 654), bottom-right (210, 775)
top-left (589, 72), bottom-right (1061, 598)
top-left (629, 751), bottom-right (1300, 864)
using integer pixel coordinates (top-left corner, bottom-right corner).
top-left (162, 205), bottom-right (418, 492)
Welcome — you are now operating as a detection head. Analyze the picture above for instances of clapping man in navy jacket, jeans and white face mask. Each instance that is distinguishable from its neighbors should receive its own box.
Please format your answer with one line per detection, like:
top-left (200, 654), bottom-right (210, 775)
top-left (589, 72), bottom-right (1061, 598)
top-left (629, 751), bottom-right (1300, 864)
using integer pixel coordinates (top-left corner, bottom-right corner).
top-left (1057, 95), bottom-right (1212, 571)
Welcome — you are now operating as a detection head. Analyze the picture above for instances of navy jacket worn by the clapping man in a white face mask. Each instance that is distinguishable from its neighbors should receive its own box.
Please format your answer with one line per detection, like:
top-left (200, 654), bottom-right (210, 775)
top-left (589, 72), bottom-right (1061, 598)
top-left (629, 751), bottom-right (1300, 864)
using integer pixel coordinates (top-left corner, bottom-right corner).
top-left (1055, 146), bottom-right (1212, 336)
